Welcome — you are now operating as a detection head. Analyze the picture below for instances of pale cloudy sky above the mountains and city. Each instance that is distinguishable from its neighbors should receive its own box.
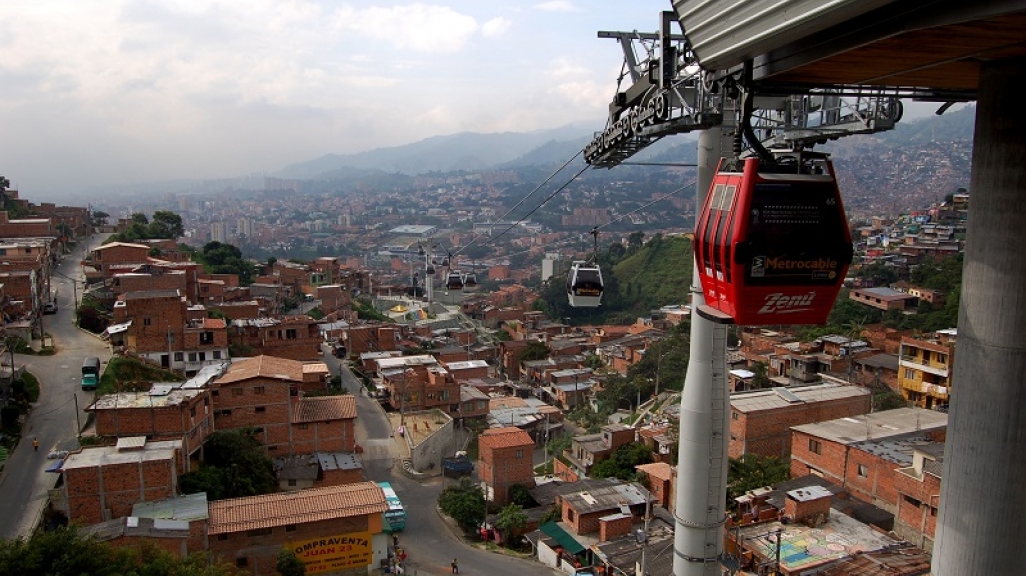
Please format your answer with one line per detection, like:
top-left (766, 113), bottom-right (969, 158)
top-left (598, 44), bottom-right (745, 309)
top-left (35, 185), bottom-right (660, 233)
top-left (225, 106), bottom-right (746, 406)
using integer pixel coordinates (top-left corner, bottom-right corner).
top-left (0, 0), bottom-right (960, 201)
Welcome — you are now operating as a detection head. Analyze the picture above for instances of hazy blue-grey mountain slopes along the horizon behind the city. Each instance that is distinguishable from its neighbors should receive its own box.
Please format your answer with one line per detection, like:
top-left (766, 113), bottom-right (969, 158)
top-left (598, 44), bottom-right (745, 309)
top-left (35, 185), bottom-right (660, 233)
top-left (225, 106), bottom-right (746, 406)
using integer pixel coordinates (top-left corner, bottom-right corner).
top-left (81, 106), bottom-right (976, 209)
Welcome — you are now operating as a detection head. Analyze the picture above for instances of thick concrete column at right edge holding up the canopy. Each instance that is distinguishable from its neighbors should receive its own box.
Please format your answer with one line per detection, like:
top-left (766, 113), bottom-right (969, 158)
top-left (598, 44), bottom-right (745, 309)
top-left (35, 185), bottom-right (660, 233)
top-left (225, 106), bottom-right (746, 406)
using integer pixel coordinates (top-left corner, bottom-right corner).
top-left (933, 60), bottom-right (1026, 576)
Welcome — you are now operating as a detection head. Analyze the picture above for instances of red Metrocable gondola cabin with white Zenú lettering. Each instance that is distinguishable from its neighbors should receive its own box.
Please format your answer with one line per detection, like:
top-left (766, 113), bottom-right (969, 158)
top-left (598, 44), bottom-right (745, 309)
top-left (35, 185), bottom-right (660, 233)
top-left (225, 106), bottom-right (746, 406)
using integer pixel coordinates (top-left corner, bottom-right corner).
top-left (695, 153), bottom-right (853, 324)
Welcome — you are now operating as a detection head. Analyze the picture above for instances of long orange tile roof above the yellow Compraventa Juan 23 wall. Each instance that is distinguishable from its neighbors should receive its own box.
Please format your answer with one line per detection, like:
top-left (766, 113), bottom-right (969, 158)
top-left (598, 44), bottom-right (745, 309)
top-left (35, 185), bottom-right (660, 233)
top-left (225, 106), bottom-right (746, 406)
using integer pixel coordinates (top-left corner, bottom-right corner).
top-left (207, 482), bottom-right (388, 535)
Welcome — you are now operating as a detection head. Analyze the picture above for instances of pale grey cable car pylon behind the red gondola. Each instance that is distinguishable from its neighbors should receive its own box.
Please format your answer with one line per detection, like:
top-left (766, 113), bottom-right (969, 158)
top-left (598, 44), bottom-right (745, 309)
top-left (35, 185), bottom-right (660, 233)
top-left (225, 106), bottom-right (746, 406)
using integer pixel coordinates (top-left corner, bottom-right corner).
top-left (673, 125), bottom-right (734, 576)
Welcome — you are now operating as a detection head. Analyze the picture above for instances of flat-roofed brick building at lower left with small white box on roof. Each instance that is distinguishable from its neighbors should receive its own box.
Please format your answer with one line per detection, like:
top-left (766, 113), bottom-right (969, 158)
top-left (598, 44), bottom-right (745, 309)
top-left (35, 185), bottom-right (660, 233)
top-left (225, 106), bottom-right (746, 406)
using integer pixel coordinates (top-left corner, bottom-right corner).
top-left (55, 436), bottom-right (182, 525)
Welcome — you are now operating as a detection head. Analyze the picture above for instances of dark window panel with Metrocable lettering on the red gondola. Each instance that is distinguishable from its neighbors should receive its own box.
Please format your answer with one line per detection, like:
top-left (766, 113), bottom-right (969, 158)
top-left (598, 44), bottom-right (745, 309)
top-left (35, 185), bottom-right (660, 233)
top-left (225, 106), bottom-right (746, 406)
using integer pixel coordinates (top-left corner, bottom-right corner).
top-left (735, 177), bottom-right (852, 285)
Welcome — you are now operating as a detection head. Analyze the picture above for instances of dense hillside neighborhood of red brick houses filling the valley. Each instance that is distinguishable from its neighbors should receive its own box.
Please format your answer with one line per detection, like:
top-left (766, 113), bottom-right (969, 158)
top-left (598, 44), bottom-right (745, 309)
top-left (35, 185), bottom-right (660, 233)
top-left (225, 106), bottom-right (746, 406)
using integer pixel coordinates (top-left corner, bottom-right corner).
top-left (0, 183), bottom-right (970, 575)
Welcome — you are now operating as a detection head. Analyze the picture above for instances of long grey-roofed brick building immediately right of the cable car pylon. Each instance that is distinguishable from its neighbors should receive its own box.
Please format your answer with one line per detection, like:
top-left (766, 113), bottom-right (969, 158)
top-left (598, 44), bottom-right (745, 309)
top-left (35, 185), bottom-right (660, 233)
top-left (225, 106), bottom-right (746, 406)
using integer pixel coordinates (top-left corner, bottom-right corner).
top-left (727, 384), bottom-right (872, 459)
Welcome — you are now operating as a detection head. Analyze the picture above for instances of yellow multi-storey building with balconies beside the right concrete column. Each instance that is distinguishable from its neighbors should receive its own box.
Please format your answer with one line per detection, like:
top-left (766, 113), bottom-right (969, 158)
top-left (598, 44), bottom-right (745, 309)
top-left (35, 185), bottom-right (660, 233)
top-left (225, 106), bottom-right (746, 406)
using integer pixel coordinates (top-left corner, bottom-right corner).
top-left (898, 329), bottom-right (957, 409)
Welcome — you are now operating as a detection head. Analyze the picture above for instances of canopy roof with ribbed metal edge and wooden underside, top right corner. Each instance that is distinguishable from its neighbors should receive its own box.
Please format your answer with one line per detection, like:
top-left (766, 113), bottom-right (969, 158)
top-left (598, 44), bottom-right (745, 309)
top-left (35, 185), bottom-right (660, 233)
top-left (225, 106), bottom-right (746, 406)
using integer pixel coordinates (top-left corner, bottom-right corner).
top-left (674, 0), bottom-right (1026, 101)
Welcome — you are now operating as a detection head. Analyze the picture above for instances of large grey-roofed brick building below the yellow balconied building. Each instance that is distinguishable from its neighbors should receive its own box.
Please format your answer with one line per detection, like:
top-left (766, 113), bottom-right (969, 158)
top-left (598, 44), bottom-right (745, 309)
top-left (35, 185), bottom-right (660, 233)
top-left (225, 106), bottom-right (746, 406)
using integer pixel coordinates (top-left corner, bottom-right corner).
top-left (791, 408), bottom-right (948, 513)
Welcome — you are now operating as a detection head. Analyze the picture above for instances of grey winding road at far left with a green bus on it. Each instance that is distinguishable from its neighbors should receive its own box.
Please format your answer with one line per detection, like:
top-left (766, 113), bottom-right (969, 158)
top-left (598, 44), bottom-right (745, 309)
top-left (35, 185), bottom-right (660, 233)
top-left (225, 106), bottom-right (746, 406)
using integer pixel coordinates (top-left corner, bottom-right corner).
top-left (0, 236), bottom-right (110, 539)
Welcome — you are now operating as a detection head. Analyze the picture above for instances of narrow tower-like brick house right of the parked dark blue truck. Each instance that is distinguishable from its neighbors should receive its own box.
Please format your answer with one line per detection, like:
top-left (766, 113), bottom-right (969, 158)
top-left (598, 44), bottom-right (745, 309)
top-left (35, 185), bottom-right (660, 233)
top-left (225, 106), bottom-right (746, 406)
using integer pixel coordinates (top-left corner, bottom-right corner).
top-left (477, 427), bottom-right (535, 506)
